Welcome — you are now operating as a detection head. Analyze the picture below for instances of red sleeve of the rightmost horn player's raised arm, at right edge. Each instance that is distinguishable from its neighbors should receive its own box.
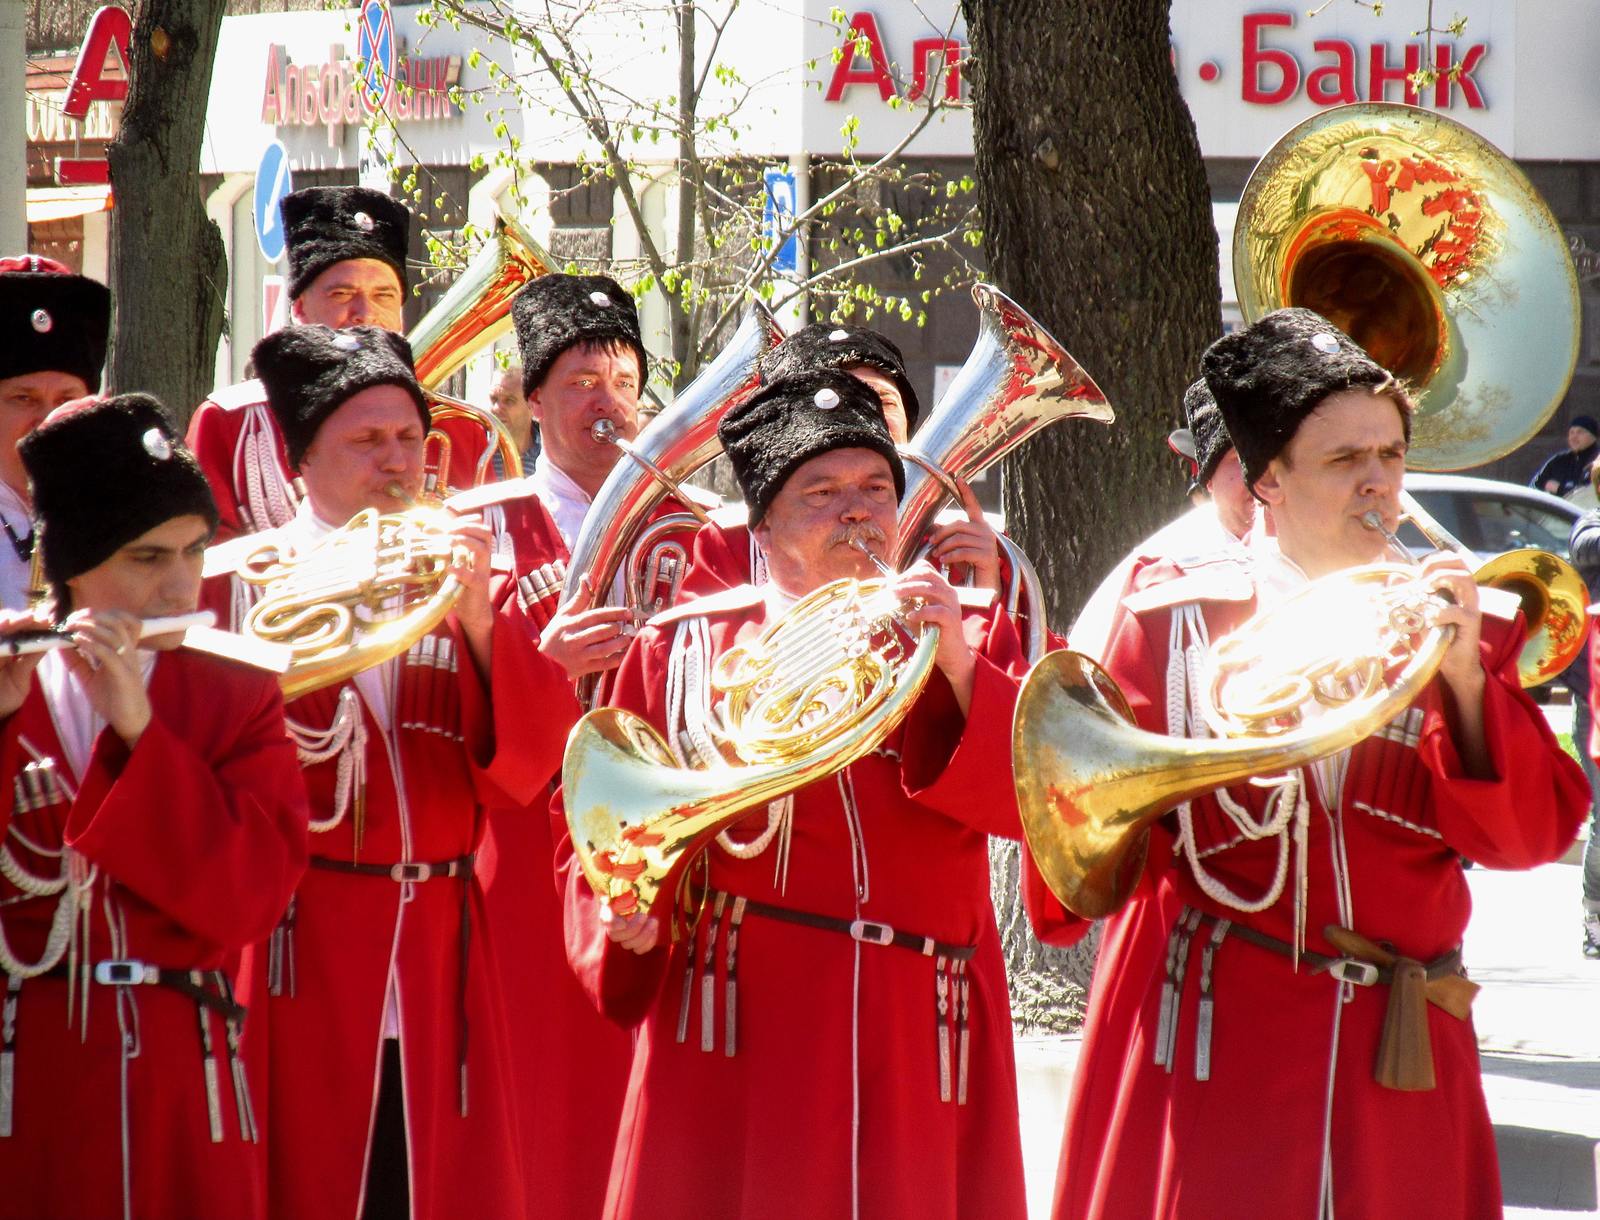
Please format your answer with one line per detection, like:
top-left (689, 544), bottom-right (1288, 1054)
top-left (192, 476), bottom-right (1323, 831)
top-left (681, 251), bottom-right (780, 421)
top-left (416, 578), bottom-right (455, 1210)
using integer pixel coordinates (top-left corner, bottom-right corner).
top-left (1418, 618), bottom-right (1590, 868)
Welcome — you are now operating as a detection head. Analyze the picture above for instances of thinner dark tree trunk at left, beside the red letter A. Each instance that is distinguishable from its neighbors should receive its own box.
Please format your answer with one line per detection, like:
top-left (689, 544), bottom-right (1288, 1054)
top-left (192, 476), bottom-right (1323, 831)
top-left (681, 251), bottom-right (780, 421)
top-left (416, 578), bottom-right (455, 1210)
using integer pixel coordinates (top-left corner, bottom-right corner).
top-left (107, 0), bottom-right (227, 424)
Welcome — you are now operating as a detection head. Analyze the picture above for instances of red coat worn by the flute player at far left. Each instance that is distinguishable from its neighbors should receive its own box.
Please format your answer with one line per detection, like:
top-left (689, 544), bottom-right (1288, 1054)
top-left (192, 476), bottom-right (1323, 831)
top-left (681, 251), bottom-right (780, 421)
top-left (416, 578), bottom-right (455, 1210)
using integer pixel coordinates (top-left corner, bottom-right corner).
top-left (0, 652), bottom-right (306, 1220)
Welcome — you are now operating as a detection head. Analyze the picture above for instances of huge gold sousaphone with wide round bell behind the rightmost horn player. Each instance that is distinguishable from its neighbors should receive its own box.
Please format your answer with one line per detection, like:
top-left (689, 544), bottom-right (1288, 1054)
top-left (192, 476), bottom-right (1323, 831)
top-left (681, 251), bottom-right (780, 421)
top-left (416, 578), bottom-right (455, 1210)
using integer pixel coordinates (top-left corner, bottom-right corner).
top-left (1234, 102), bottom-right (1587, 685)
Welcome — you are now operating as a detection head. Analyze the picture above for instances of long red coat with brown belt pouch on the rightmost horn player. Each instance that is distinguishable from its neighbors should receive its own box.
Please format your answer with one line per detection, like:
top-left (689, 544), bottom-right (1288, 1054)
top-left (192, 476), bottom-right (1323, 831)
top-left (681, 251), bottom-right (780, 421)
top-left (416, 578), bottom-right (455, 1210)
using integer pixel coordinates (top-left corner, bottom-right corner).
top-left (1024, 564), bottom-right (1587, 1220)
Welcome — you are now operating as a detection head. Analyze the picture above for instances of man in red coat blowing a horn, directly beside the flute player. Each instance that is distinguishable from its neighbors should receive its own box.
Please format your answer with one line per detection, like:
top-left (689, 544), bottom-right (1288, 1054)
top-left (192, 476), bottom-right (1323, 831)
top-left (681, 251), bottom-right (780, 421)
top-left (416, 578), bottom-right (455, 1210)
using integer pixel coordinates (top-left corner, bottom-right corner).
top-left (233, 327), bottom-right (578, 1220)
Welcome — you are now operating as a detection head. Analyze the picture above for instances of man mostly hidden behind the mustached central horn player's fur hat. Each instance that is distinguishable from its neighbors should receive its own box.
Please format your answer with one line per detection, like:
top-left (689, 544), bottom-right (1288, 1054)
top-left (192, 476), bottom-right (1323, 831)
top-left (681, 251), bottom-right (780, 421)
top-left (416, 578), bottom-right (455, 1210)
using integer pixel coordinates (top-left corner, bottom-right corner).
top-left (683, 322), bottom-right (1002, 597)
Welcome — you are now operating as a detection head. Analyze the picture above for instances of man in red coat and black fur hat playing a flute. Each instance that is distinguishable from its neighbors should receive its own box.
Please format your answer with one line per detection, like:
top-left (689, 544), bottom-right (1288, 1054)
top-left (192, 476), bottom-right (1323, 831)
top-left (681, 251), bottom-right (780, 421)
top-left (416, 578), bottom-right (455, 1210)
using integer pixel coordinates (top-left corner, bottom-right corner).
top-left (0, 394), bottom-right (306, 1217)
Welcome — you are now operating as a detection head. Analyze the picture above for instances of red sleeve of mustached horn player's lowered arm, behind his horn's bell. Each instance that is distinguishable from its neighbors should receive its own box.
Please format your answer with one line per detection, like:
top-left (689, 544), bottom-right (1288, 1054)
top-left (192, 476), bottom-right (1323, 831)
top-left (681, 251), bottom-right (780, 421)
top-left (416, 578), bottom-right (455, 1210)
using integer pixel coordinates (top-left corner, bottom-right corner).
top-left (550, 628), bottom-right (670, 1026)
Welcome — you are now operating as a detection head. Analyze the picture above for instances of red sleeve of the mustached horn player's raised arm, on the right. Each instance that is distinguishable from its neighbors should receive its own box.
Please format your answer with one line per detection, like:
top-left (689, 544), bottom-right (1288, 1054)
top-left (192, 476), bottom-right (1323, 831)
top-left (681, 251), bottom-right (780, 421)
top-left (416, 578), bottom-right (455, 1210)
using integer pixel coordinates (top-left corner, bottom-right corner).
top-left (901, 605), bottom-right (1022, 839)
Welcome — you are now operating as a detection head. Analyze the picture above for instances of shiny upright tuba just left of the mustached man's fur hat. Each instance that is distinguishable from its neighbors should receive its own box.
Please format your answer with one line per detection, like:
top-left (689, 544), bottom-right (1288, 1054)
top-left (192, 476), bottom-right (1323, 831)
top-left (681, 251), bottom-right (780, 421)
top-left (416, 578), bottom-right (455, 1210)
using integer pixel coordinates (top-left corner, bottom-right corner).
top-left (563, 301), bottom-right (782, 615)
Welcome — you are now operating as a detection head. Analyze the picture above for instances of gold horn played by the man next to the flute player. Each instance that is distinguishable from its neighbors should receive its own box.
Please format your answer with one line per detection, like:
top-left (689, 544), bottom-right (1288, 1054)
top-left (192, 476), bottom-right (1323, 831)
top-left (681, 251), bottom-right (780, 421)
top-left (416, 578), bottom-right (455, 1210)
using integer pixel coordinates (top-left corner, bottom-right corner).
top-left (235, 508), bottom-right (461, 698)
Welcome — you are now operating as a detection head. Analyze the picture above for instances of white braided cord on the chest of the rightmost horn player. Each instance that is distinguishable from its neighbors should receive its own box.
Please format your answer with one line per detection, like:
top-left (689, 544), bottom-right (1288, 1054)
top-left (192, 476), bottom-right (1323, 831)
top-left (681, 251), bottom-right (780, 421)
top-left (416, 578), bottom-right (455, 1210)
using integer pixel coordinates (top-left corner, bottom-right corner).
top-left (1166, 604), bottom-right (1310, 948)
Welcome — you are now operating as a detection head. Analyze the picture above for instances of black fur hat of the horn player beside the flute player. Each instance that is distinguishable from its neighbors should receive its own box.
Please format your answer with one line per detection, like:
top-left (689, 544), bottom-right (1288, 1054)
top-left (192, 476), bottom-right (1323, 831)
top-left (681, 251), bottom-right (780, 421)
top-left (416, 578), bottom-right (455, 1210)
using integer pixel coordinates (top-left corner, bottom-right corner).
top-left (250, 327), bottom-right (430, 469)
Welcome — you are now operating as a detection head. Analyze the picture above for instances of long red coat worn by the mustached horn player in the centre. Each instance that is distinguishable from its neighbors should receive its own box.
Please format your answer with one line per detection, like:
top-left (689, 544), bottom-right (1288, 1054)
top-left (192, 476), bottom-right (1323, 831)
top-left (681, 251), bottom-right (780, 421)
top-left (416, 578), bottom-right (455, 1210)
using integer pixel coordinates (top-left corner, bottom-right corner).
top-left (554, 596), bottom-right (1024, 1217)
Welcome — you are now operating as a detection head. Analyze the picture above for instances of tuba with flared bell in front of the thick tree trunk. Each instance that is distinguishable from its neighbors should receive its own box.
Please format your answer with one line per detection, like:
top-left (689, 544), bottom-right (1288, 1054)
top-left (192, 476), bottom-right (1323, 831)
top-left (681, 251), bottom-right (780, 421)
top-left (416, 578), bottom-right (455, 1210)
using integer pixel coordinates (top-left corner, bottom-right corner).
top-left (894, 283), bottom-right (1115, 661)
